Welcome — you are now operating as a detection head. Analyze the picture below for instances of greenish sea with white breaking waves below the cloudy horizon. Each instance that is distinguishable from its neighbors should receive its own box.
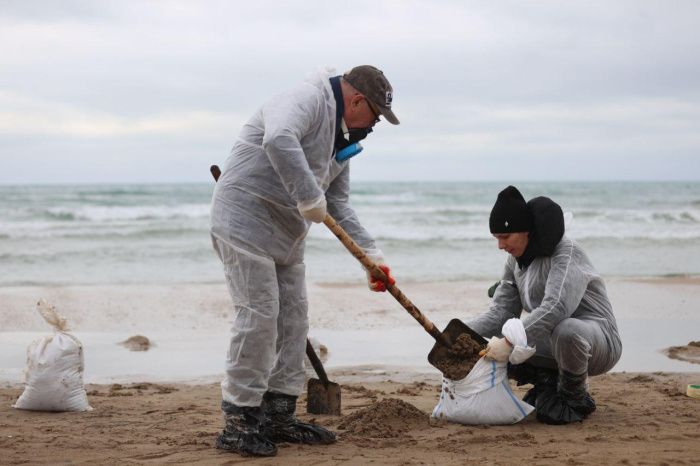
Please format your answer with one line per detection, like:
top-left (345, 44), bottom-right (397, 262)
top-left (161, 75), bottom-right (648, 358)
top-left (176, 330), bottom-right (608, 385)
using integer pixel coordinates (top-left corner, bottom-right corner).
top-left (0, 182), bottom-right (700, 286)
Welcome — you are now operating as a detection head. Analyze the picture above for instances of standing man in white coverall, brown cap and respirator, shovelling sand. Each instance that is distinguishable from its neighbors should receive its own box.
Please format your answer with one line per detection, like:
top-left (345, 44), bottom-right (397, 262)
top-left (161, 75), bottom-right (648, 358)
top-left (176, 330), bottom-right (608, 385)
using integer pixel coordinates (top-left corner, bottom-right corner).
top-left (211, 65), bottom-right (399, 456)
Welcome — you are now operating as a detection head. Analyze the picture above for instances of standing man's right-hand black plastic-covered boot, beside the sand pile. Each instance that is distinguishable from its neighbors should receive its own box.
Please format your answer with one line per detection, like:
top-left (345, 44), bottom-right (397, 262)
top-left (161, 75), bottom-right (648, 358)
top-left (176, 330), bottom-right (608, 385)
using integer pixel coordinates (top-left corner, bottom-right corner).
top-left (261, 392), bottom-right (336, 445)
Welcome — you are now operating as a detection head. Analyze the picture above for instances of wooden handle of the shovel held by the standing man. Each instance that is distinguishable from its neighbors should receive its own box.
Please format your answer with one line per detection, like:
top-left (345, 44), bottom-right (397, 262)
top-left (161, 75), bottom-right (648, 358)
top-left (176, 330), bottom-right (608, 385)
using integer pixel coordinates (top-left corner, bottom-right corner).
top-left (323, 214), bottom-right (452, 348)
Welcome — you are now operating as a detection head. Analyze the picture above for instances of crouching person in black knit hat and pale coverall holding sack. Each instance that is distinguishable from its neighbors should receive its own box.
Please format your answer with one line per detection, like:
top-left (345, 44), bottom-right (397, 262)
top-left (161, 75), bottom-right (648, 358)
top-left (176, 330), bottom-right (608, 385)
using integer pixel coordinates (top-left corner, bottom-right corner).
top-left (474, 186), bottom-right (622, 424)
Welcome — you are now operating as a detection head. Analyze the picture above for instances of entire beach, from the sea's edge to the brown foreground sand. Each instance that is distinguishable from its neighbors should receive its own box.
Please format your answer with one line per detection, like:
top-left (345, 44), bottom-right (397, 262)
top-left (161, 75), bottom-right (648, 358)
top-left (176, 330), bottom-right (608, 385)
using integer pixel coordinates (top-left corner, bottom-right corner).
top-left (0, 277), bottom-right (700, 464)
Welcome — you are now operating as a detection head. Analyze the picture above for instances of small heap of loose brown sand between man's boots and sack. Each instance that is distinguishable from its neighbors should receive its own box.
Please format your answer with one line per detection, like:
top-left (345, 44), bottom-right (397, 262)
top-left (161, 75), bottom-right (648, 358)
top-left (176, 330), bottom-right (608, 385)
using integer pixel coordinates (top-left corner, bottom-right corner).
top-left (338, 398), bottom-right (429, 438)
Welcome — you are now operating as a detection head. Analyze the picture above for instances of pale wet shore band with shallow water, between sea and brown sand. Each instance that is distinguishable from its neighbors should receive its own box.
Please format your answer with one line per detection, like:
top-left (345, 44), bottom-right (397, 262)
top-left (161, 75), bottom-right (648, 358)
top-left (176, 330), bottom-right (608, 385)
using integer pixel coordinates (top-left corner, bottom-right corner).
top-left (0, 277), bottom-right (700, 383)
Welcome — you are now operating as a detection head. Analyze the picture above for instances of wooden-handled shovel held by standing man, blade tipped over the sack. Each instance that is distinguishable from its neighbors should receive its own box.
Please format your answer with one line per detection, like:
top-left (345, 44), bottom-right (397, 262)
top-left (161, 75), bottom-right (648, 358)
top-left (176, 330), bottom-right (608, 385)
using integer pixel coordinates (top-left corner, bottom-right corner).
top-left (323, 214), bottom-right (487, 372)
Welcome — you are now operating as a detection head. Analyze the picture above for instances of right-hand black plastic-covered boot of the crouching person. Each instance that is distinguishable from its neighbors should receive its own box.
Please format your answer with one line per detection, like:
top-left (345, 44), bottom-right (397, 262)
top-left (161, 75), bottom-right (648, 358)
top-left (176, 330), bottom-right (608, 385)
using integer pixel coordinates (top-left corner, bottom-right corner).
top-left (535, 370), bottom-right (595, 424)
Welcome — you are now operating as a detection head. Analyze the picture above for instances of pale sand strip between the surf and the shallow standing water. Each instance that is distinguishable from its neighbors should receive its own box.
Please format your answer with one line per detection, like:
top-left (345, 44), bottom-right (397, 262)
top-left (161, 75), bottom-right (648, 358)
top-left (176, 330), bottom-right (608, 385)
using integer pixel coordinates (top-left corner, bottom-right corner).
top-left (0, 276), bottom-right (700, 333)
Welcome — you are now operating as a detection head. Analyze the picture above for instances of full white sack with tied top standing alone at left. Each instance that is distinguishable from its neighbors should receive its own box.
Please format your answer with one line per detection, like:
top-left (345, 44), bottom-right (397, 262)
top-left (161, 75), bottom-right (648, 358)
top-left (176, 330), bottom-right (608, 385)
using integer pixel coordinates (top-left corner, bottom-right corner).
top-left (13, 299), bottom-right (92, 411)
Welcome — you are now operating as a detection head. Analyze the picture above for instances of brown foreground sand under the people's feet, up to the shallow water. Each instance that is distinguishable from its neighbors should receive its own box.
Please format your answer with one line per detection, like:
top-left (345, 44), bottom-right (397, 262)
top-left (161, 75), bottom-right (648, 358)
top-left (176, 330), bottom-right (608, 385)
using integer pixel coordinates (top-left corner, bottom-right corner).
top-left (0, 370), bottom-right (700, 465)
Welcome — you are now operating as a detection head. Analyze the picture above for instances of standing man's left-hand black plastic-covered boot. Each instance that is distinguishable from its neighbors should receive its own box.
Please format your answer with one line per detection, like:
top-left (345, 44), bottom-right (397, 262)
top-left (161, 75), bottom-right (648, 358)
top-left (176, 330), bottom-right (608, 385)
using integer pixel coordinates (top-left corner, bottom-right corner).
top-left (216, 401), bottom-right (277, 456)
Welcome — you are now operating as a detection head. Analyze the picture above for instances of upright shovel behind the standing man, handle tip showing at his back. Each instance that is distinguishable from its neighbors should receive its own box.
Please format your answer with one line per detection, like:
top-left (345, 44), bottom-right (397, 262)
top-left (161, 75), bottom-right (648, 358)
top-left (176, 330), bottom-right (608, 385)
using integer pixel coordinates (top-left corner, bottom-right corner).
top-left (209, 165), bottom-right (340, 416)
